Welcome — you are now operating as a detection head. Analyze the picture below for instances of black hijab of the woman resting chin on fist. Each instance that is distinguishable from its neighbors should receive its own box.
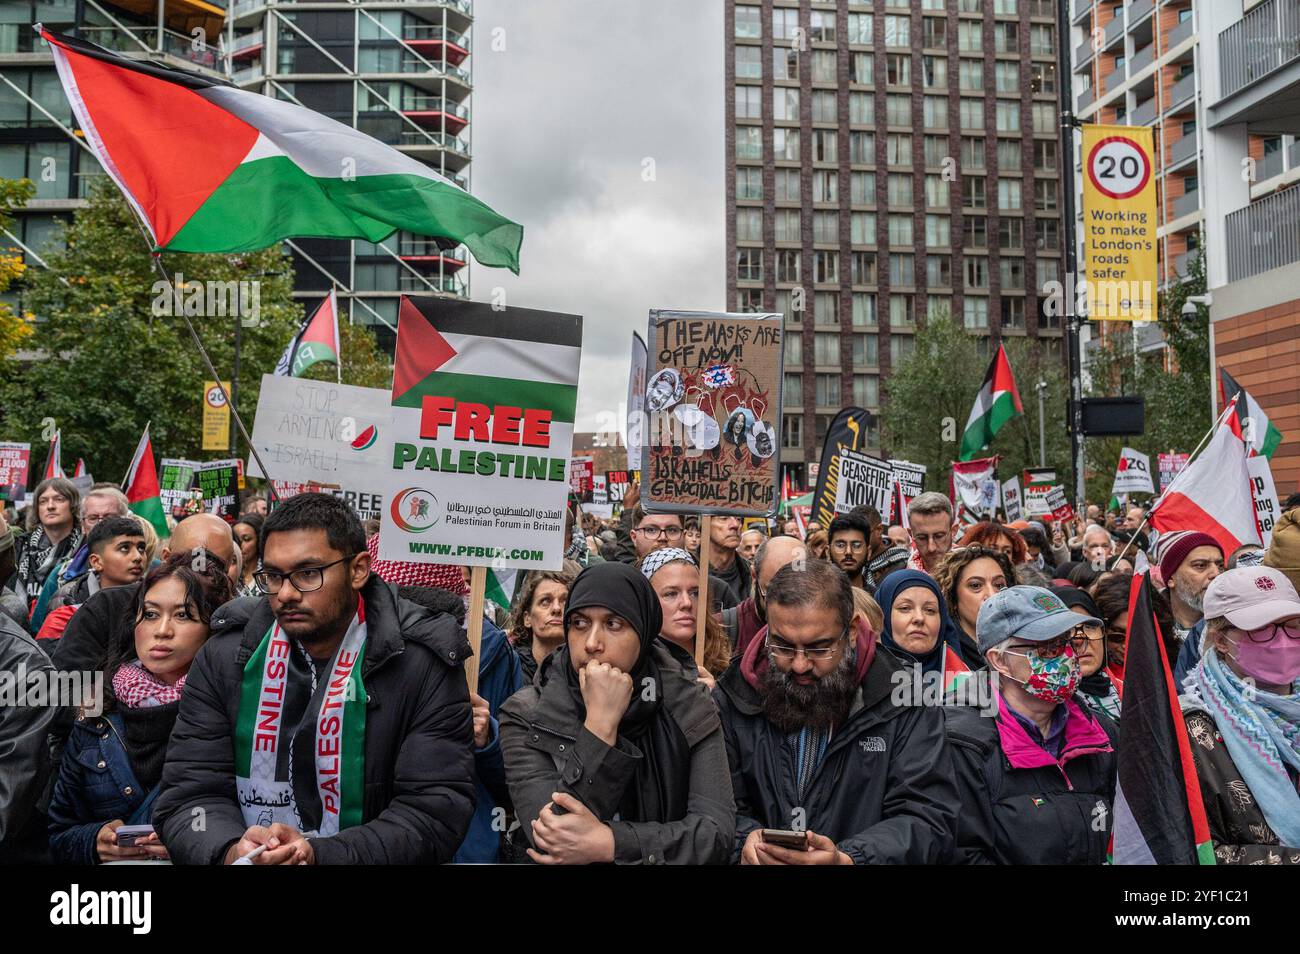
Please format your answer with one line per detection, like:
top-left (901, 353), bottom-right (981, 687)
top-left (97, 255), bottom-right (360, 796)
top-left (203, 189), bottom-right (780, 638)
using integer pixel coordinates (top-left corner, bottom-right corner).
top-left (561, 563), bottom-right (690, 823)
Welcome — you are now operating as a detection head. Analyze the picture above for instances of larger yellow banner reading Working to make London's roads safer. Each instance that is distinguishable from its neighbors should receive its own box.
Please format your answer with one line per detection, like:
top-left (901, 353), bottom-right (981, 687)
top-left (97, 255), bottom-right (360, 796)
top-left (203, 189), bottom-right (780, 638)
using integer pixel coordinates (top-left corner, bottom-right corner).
top-left (1083, 125), bottom-right (1158, 321)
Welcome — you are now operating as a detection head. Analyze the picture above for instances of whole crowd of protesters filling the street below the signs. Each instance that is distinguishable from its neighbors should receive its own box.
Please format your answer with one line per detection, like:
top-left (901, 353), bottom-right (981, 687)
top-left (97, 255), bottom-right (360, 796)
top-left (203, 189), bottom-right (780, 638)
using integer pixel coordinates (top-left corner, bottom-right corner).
top-left (0, 478), bottom-right (1300, 864)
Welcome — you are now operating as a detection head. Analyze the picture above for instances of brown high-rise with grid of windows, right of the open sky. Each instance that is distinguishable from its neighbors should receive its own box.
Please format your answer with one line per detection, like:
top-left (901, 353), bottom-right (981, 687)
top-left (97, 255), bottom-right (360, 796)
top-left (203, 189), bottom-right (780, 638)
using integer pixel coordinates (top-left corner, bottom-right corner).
top-left (725, 0), bottom-right (1063, 481)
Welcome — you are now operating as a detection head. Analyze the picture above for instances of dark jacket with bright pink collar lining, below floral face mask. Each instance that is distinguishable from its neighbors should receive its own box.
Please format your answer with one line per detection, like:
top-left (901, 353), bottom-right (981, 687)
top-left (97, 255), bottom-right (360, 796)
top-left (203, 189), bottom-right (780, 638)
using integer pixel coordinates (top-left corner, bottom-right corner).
top-left (944, 671), bottom-right (1118, 864)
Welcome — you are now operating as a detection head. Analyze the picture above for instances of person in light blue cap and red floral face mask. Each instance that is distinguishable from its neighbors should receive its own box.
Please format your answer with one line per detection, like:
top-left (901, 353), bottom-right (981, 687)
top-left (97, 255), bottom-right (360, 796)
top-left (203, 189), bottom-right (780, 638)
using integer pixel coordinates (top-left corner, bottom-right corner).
top-left (944, 586), bottom-right (1117, 864)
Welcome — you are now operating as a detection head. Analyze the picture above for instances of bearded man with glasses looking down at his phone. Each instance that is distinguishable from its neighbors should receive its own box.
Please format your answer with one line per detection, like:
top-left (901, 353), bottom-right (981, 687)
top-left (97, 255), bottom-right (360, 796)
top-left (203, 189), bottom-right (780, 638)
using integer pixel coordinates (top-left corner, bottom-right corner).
top-left (714, 559), bottom-right (957, 864)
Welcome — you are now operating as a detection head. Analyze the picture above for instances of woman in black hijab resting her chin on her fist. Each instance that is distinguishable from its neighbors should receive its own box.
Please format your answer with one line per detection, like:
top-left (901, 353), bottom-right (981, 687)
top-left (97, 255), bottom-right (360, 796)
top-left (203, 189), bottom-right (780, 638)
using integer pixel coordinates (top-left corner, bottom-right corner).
top-left (501, 563), bottom-right (736, 864)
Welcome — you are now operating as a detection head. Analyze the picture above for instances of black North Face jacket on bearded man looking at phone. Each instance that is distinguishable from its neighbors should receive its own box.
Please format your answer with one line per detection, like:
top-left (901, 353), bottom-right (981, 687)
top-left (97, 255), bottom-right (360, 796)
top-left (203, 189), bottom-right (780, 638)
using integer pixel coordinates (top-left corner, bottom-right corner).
top-left (714, 626), bottom-right (957, 864)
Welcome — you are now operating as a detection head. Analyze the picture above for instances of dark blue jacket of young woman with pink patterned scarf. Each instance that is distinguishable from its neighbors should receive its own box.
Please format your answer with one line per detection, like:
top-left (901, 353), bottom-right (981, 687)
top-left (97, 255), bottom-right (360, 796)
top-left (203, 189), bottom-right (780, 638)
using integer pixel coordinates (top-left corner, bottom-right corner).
top-left (49, 715), bottom-right (159, 864)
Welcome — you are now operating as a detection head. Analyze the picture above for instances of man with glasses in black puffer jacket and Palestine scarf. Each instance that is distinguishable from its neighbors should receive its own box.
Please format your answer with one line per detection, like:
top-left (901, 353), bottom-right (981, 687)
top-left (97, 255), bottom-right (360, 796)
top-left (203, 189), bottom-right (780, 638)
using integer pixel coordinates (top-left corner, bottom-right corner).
top-left (153, 494), bottom-right (475, 864)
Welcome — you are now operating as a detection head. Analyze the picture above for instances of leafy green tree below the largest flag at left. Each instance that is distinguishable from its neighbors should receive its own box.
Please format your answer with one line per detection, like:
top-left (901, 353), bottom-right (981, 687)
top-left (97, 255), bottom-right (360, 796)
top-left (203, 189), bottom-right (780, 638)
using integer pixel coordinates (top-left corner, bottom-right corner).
top-left (0, 177), bottom-right (302, 480)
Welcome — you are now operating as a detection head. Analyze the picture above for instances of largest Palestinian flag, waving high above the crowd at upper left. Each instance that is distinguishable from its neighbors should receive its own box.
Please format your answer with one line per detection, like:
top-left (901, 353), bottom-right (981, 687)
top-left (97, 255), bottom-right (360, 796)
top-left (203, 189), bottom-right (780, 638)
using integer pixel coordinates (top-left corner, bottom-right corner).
top-left (35, 23), bottom-right (524, 273)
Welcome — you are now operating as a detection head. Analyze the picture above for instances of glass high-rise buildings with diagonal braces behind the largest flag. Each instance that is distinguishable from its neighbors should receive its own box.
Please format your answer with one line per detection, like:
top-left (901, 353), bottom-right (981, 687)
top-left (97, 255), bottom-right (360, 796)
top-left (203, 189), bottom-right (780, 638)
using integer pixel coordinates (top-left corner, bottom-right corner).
top-left (0, 0), bottom-right (473, 350)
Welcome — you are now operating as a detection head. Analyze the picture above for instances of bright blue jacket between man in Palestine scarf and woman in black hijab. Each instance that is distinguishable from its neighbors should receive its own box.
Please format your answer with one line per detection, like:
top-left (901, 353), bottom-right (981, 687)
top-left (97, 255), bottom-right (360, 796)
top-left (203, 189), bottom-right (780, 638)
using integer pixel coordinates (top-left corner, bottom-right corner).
top-left (451, 619), bottom-right (524, 864)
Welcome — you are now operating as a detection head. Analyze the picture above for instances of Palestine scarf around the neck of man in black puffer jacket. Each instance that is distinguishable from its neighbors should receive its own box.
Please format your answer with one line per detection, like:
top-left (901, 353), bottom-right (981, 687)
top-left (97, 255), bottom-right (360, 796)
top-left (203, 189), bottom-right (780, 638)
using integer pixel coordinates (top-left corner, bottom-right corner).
top-left (235, 597), bottom-right (367, 836)
